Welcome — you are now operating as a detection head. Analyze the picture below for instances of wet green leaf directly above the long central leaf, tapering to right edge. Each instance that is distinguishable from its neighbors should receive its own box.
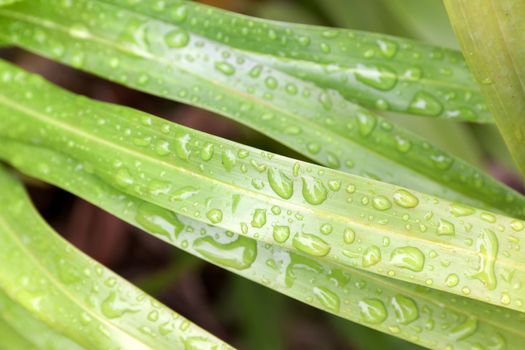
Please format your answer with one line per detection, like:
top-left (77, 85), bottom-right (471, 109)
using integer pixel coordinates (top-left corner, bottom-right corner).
top-left (0, 0), bottom-right (508, 209)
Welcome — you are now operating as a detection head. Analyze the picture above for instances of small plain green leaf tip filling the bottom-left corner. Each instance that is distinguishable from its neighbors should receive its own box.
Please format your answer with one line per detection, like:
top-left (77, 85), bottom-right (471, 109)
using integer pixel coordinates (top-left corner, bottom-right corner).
top-left (0, 291), bottom-right (85, 350)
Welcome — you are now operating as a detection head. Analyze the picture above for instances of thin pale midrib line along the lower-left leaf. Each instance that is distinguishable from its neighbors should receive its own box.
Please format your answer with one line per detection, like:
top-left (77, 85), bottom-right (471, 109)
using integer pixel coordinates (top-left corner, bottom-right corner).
top-left (0, 215), bottom-right (152, 349)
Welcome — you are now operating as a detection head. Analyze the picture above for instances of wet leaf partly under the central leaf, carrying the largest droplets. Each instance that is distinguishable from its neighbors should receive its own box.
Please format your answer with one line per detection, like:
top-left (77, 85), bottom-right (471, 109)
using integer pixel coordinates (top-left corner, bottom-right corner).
top-left (0, 139), bottom-right (525, 350)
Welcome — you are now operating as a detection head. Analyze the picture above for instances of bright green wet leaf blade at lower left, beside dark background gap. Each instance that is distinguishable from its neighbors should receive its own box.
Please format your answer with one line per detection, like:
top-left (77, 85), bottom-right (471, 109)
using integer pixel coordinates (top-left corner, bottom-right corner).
top-left (0, 170), bottom-right (233, 349)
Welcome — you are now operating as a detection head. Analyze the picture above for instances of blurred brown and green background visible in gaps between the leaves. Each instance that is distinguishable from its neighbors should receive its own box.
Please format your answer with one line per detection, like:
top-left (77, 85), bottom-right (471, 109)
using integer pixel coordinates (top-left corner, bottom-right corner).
top-left (0, 0), bottom-right (522, 350)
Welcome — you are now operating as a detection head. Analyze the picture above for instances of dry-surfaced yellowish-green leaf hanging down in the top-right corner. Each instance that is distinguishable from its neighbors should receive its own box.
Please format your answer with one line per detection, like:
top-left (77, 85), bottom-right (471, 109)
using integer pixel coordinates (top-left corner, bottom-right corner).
top-left (445, 0), bottom-right (525, 176)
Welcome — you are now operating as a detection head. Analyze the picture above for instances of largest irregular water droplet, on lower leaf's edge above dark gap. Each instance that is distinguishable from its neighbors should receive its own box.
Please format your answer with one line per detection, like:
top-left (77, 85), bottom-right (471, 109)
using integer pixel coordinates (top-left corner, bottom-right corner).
top-left (193, 236), bottom-right (257, 270)
